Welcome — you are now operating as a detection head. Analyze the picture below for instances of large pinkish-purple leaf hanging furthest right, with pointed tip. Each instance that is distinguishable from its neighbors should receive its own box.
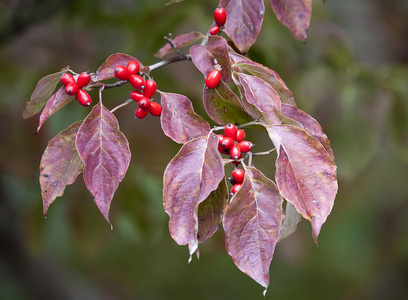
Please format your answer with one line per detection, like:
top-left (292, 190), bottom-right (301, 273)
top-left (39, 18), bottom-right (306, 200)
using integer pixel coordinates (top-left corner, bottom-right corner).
top-left (266, 125), bottom-right (338, 244)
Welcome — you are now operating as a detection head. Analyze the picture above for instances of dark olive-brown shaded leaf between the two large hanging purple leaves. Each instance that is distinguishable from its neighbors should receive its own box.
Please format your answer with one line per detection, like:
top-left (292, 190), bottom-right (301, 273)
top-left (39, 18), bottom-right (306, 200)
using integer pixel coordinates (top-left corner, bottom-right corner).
top-left (197, 179), bottom-right (228, 243)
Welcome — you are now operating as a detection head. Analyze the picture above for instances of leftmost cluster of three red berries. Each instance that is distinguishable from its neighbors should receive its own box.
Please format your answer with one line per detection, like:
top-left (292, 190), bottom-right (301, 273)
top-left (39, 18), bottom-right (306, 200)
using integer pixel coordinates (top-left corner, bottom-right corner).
top-left (61, 72), bottom-right (92, 106)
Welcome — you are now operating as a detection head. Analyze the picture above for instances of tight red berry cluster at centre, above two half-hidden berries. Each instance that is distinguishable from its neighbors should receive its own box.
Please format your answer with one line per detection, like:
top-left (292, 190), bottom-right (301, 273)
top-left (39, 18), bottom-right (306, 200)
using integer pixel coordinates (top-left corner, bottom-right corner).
top-left (218, 123), bottom-right (254, 165)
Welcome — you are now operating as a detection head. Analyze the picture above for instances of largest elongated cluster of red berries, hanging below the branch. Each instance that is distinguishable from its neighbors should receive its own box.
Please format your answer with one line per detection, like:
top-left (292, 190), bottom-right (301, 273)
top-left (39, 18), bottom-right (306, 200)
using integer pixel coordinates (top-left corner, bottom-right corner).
top-left (114, 60), bottom-right (162, 119)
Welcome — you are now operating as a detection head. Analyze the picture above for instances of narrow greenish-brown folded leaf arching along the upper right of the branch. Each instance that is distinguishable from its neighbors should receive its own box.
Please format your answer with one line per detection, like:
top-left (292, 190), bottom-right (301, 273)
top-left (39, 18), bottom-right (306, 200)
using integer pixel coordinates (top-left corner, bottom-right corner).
top-left (230, 53), bottom-right (296, 106)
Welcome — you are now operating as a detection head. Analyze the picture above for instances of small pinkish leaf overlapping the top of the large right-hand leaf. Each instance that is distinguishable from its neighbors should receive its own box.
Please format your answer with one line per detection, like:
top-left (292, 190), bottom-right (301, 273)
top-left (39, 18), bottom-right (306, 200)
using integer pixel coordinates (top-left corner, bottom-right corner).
top-left (237, 73), bottom-right (282, 125)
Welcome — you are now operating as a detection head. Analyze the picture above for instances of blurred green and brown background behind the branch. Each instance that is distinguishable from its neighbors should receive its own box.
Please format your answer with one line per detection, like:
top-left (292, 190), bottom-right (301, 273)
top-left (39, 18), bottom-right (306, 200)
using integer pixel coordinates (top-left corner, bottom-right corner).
top-left (0, 0), bottom-right (408, 300)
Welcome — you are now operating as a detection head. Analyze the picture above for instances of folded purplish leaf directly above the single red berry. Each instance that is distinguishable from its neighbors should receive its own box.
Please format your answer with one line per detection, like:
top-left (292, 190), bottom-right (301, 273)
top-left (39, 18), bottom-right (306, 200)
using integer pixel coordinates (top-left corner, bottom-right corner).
top-left (190, 36), bottom-right (231, 82)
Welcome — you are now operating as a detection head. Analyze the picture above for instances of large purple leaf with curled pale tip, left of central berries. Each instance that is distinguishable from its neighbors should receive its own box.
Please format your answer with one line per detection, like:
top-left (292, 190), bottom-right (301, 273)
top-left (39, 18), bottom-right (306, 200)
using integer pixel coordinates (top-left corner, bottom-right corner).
top-left (163, 132), bottom-right (225, 259)
